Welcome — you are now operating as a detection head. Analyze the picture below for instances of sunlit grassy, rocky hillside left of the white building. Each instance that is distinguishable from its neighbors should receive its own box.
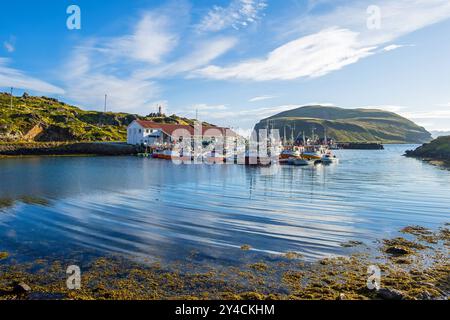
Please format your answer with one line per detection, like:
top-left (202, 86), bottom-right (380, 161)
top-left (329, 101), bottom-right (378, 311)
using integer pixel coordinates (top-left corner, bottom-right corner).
top-left (0, 93), bottom-right (204, 142)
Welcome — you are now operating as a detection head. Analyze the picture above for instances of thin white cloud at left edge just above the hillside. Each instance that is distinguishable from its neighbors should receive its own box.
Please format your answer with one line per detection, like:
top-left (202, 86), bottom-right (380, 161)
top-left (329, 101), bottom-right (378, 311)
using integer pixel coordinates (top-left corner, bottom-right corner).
top-left (0, 57), bottom-right (64, 94)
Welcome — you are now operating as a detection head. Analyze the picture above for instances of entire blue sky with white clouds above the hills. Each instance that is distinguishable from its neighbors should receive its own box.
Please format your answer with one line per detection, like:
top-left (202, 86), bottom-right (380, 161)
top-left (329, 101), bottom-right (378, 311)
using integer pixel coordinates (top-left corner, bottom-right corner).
top-left (0, 0), bottom-right (450, 133)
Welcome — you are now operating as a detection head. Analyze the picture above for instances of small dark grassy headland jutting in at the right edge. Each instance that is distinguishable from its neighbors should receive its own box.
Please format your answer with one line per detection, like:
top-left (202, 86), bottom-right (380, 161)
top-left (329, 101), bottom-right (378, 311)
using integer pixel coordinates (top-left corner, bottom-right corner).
top-left (405, 136), bottom-right (450, 167)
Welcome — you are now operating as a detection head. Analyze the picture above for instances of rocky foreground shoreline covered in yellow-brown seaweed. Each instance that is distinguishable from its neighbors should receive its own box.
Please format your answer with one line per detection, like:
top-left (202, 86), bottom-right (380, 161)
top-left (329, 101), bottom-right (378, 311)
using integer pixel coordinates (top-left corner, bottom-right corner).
top-left (0, 224), bottom-right (450, 300)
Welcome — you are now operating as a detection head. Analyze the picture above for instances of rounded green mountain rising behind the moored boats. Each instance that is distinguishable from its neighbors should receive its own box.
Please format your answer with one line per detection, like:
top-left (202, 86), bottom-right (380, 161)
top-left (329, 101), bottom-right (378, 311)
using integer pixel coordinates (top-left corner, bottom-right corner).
top-left (255, 105), bottom-right (432, 143)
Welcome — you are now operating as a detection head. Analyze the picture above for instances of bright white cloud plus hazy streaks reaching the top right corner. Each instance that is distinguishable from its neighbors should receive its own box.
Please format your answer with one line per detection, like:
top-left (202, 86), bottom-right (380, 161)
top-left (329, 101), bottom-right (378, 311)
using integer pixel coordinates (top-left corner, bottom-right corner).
top-left (195, 0), bottom-right (450, 81)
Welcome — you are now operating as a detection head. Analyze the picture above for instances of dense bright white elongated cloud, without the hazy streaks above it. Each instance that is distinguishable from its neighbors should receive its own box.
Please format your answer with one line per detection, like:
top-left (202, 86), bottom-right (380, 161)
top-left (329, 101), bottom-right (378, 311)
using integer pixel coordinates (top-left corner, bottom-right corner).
top-left (195, 28), bottom-right (375, 81)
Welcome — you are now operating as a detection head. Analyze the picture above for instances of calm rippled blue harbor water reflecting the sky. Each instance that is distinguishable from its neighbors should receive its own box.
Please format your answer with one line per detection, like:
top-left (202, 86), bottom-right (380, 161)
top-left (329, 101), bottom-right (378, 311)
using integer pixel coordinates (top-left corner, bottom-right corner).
top-left (0, 145), bottom-right (450, 264)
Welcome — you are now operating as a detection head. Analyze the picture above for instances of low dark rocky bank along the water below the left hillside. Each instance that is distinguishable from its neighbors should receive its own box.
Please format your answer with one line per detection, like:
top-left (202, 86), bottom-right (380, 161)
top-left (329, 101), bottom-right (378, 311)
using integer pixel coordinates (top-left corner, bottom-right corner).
top-left (0, 142), bottom-right (138, 157)
